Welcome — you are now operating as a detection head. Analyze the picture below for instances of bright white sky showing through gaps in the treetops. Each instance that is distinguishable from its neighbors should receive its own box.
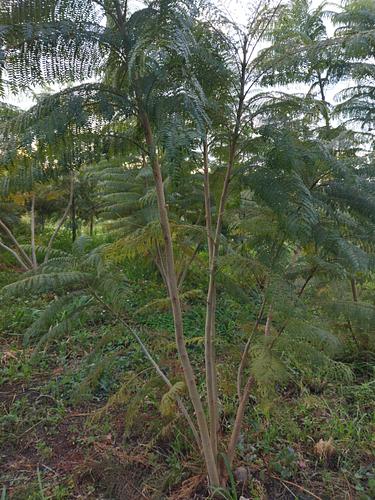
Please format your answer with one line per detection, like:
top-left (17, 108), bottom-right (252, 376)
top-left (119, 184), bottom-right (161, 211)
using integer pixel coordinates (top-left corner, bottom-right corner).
top-left (5, 0), bottom-right (342, 109)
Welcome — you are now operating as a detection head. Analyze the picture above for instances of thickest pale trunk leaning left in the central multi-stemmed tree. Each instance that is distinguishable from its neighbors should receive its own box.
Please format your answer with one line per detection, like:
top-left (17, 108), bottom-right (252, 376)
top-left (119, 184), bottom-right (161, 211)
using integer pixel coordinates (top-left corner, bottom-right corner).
top-left (139, 109), bottom-right (219, 486)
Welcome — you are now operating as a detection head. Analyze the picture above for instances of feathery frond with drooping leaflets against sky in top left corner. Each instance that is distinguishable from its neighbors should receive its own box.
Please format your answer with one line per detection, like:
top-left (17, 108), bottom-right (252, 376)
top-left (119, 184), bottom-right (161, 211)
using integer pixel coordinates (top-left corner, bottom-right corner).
top-left (0, 0), bottom-right (108, 89)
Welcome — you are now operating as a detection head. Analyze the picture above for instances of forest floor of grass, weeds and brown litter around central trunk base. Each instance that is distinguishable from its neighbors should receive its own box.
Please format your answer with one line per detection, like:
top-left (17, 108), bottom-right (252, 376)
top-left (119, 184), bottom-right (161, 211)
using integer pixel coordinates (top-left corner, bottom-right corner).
top-left (0, 270), bottom-right (375, 500)
